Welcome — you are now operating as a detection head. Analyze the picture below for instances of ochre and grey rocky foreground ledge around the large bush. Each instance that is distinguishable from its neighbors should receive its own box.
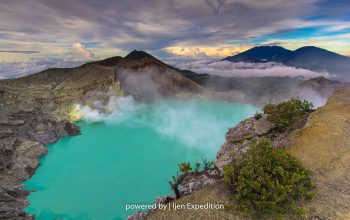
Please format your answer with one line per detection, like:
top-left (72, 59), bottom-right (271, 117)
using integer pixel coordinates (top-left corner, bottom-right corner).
top-left (147, 90), bottom-right (350, 219)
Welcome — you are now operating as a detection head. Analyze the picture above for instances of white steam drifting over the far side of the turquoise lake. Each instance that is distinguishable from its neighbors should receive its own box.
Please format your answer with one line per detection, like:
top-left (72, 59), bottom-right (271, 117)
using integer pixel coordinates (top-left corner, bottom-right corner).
top-left (75, 96), bottom-right (257, 150)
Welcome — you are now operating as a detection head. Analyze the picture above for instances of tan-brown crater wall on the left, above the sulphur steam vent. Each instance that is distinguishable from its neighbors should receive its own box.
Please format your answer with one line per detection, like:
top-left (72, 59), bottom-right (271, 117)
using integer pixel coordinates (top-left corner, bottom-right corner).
top-left (0, 64), bottom-right (122, 121)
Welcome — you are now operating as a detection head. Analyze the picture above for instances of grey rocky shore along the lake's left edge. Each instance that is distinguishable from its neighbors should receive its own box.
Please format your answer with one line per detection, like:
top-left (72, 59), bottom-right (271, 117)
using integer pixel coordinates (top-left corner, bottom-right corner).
top-left (0, 111), bottom-right (80, 219)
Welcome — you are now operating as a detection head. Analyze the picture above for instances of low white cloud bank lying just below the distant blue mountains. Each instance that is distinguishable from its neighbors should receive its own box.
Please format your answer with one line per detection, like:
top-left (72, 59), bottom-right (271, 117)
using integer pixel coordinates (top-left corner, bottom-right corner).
top-left (177, 60), bottom-right (329, 78)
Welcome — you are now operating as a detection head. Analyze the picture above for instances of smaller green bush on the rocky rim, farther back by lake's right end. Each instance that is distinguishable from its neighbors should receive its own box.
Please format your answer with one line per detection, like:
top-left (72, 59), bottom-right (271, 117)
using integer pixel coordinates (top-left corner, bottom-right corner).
top-left (264, 98), bottom-right (313, 130)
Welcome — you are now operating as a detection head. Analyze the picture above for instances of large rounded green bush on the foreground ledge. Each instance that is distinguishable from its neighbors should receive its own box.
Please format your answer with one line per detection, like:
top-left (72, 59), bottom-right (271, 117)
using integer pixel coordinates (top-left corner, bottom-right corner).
top-left (224, 139), bottom-right (314, 214)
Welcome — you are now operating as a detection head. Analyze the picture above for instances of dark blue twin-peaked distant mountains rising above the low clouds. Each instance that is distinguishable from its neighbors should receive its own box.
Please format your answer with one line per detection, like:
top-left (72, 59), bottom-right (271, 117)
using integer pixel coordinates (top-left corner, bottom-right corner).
top-left (223, 46), bottom-right (350, 79)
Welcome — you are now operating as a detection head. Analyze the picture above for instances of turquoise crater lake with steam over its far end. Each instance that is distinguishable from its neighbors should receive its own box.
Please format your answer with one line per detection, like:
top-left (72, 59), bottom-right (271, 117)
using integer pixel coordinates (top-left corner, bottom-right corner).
top-left (25, 101), bottom-right (258, 220)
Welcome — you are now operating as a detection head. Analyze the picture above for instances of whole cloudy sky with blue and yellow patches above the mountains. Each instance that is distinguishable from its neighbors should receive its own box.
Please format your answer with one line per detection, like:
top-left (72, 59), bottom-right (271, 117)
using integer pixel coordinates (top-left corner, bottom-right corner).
top-left (0, 0), bottom-right (350, 77)
